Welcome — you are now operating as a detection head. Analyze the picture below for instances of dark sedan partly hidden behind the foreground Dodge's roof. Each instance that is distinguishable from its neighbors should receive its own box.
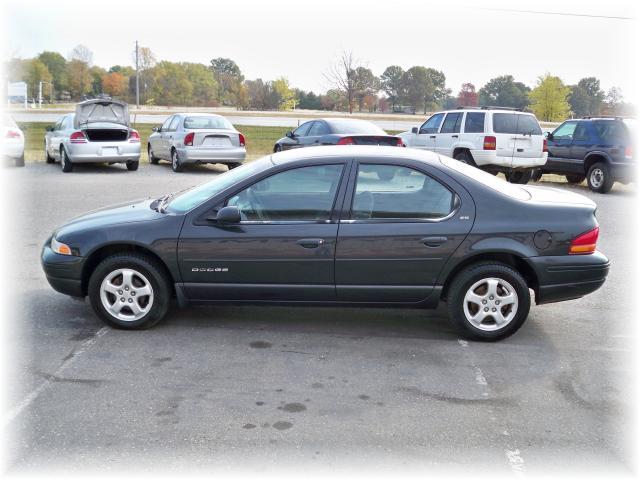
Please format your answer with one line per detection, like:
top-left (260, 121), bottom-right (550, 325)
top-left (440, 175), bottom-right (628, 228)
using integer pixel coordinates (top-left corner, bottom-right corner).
top-left (273, 118), bottom-right (404, 152)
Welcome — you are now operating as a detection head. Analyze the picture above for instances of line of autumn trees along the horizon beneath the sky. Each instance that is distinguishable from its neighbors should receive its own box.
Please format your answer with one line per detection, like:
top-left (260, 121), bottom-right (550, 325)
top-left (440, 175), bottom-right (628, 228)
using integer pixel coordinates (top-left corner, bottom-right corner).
top-left (5, 45), bottom-right (633, 121)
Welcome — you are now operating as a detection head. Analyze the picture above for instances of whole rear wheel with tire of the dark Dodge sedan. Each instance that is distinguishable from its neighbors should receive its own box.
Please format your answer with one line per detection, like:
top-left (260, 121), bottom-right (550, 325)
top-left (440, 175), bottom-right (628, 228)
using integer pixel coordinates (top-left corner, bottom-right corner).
top-left (447, 263), bottom-right (531, 341)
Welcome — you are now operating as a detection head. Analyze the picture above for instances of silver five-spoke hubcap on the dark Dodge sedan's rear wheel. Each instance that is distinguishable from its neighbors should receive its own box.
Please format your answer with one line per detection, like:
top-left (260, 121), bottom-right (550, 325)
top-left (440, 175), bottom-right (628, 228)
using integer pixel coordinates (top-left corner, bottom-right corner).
top-left (463, 277), bottom-right (518, 332)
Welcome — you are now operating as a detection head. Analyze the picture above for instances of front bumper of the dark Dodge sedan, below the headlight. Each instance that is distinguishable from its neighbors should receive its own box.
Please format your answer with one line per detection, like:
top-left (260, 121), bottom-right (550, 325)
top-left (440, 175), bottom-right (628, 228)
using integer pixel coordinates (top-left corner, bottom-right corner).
top-left (40, 246), bottom-right (85, 297)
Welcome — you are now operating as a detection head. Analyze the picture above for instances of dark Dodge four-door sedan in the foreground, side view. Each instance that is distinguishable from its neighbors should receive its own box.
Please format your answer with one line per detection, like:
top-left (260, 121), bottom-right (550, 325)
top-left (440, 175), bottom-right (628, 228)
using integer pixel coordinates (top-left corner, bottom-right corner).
top-left (42, 146), bottom-right (609, 340)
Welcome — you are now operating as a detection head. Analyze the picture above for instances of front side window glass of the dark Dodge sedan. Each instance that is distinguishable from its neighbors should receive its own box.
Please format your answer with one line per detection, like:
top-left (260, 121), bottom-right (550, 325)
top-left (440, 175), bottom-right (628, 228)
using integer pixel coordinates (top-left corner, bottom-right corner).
top-left (227, 165), bottom-right (342, 222)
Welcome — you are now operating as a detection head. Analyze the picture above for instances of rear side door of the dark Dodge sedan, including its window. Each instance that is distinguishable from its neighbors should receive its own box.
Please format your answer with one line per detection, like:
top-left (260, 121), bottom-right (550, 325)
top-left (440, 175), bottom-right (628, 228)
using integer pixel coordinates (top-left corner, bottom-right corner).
top-left (335, 159), bottom-right (475, 303)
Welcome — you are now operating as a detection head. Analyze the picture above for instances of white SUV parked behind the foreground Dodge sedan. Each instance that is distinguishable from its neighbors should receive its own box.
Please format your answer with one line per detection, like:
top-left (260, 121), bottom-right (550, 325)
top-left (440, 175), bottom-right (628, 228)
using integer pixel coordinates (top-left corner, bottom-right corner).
top-left (398, 107), bottom-right (547, 183)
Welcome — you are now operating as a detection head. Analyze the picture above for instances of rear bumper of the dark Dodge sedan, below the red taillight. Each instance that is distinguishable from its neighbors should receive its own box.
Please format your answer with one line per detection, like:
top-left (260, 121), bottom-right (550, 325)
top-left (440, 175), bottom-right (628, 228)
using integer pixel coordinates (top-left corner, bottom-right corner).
top-left (527, 252), bottom-right (610, 305)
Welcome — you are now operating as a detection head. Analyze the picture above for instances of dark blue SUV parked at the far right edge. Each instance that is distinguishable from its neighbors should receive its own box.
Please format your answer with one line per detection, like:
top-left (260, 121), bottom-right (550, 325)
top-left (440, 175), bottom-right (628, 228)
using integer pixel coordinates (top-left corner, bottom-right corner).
top-left (536, 117), bottom-right (637, 193)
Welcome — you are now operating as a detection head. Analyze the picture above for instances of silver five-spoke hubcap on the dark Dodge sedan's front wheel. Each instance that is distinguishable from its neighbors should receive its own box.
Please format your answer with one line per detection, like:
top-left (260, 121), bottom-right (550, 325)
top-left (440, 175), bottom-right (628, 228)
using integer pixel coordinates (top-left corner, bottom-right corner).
top-left (100, 268), bottom-right (153, 322)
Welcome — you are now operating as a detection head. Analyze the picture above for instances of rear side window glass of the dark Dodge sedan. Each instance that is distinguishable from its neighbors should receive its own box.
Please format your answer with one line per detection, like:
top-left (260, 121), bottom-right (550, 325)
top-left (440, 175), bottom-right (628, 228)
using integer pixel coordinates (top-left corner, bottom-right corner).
top-left (351, 164), bottom-right (455, 220)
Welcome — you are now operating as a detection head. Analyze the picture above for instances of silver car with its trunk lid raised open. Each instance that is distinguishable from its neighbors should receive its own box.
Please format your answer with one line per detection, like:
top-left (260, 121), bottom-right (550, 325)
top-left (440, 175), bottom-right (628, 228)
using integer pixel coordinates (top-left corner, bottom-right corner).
top-left (44, 97), bottom-right (140, 172)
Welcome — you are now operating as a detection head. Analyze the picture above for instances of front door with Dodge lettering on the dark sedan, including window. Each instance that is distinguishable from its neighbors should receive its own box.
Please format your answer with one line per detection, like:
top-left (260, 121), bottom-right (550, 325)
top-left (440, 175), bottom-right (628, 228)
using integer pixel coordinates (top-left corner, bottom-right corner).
top-left (178, 159), bottom-right (349, 301)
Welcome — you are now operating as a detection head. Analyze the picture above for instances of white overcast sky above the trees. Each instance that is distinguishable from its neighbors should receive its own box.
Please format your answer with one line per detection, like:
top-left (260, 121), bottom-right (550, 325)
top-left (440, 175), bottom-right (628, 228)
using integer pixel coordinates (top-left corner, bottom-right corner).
top-left (3, 0), bottom-right (640, 101)
